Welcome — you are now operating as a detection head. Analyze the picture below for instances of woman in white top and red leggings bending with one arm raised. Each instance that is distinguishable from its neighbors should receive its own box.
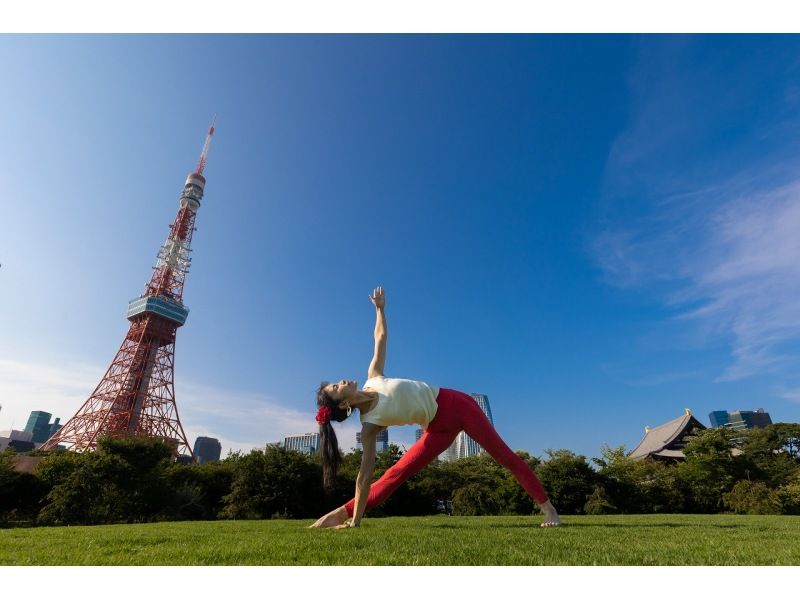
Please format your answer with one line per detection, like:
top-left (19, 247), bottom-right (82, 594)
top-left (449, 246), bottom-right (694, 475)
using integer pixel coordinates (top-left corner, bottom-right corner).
top-left (311, 287), bottom-right (561, 528)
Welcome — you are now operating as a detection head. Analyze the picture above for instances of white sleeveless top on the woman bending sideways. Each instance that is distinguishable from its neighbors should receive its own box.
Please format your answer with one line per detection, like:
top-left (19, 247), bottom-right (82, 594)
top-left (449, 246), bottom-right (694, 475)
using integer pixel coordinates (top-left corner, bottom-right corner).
top-left (361, 376), bottom-right (439, 428)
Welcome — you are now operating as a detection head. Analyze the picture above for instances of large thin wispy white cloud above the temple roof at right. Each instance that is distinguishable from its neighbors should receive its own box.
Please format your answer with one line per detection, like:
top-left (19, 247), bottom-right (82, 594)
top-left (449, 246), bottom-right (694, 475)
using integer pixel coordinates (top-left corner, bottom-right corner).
top-left (591, 39), bottom-right (800, 390)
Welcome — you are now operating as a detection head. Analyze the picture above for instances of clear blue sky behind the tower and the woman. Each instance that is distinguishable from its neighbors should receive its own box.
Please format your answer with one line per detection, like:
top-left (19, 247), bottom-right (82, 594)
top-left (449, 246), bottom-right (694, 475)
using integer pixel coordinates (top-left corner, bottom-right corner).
top-left (0, 35), bottom-right (800, 456)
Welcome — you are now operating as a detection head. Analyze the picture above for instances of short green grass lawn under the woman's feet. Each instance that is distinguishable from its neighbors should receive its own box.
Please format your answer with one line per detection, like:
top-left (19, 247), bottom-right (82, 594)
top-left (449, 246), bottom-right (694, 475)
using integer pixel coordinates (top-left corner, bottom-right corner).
top-left (0, 515), bottom-right (800, 565)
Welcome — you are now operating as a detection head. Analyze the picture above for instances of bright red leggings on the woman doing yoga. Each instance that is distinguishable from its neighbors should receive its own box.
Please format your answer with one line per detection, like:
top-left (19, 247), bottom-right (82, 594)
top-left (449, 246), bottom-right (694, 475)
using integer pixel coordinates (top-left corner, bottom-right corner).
top-left (344, 388), bottom-right (547, 517)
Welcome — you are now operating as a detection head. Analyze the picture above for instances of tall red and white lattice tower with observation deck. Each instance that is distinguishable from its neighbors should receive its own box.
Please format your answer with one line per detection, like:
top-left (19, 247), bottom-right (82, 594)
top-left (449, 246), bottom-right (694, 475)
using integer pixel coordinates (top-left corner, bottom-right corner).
top-left (41, 115), bottom-right (216, 458)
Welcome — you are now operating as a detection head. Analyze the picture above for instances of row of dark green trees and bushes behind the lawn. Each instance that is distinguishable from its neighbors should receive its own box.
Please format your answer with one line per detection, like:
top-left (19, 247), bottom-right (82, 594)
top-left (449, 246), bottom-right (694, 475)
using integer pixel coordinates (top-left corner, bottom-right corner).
top-left (0, 424), bottom-right (800, 526)
